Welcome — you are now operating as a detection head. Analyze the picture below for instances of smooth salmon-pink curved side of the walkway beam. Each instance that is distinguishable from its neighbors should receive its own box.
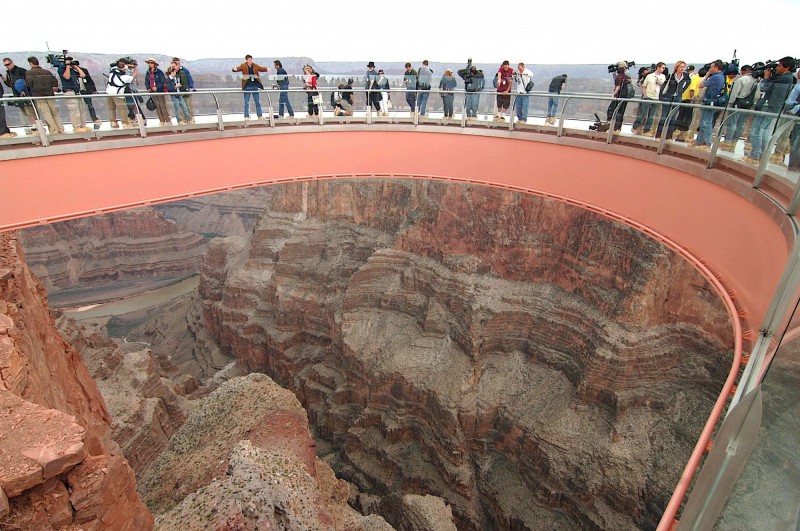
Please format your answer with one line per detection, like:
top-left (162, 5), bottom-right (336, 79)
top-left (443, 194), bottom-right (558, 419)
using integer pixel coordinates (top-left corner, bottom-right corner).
top-left (0, 131), bottom-right (788, 329)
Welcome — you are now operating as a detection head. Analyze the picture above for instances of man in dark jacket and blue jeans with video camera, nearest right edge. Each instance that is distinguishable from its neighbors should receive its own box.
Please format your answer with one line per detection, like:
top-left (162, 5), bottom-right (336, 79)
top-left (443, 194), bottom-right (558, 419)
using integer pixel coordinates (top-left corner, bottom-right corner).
top-left (741, 56), bottom-right (795, 164)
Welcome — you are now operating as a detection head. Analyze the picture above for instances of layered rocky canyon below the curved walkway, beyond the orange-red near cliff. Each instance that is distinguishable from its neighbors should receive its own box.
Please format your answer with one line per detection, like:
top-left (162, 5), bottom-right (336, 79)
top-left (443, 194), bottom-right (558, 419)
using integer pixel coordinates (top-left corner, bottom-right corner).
top-left (0, 179), bottom-right (733, 529)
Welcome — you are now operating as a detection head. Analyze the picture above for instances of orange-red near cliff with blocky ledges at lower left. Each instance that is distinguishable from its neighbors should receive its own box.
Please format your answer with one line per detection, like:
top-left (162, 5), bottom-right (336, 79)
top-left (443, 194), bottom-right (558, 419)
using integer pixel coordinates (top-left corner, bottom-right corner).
top-left (0, 233), bottom-right (153, 530)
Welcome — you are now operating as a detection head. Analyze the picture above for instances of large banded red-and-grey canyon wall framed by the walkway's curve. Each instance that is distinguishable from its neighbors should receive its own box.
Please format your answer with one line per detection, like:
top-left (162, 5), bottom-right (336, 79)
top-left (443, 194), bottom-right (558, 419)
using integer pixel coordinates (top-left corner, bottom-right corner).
top-left (200, 180), bottom-right (733, 529)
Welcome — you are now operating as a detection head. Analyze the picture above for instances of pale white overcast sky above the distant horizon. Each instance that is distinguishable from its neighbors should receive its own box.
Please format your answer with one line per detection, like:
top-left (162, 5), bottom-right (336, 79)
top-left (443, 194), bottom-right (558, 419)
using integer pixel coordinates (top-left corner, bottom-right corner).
top-left (7, 0), bottom-right (800, 64)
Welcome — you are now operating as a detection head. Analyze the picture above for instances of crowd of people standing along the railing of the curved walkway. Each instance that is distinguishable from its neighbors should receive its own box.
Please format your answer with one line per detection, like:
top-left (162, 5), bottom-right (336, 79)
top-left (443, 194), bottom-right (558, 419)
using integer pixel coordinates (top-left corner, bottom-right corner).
top-left (0, 52), bottom-right (800, 170)
